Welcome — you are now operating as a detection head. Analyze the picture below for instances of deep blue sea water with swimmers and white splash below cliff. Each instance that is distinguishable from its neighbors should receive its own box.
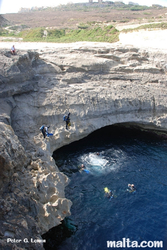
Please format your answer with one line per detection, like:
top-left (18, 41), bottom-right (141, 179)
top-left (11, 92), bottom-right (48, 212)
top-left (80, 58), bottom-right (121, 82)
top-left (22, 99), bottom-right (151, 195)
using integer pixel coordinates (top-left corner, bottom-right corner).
top-left (54, 126), bottom-right (167, 250)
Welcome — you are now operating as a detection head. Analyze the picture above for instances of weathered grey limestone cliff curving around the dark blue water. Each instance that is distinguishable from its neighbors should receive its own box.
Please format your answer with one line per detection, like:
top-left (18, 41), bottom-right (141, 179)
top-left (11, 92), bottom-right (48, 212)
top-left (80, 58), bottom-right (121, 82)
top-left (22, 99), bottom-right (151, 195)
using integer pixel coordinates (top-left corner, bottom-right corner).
top-left (0, 43), bottom-right (167, 249)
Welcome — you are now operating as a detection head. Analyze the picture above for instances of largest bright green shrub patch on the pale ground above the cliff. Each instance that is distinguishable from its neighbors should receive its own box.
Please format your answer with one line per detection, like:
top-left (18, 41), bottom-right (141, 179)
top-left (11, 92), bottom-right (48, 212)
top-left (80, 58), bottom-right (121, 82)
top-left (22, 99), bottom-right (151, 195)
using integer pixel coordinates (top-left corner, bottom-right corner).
top-left (18, 24), bottom-right (119, 43)
